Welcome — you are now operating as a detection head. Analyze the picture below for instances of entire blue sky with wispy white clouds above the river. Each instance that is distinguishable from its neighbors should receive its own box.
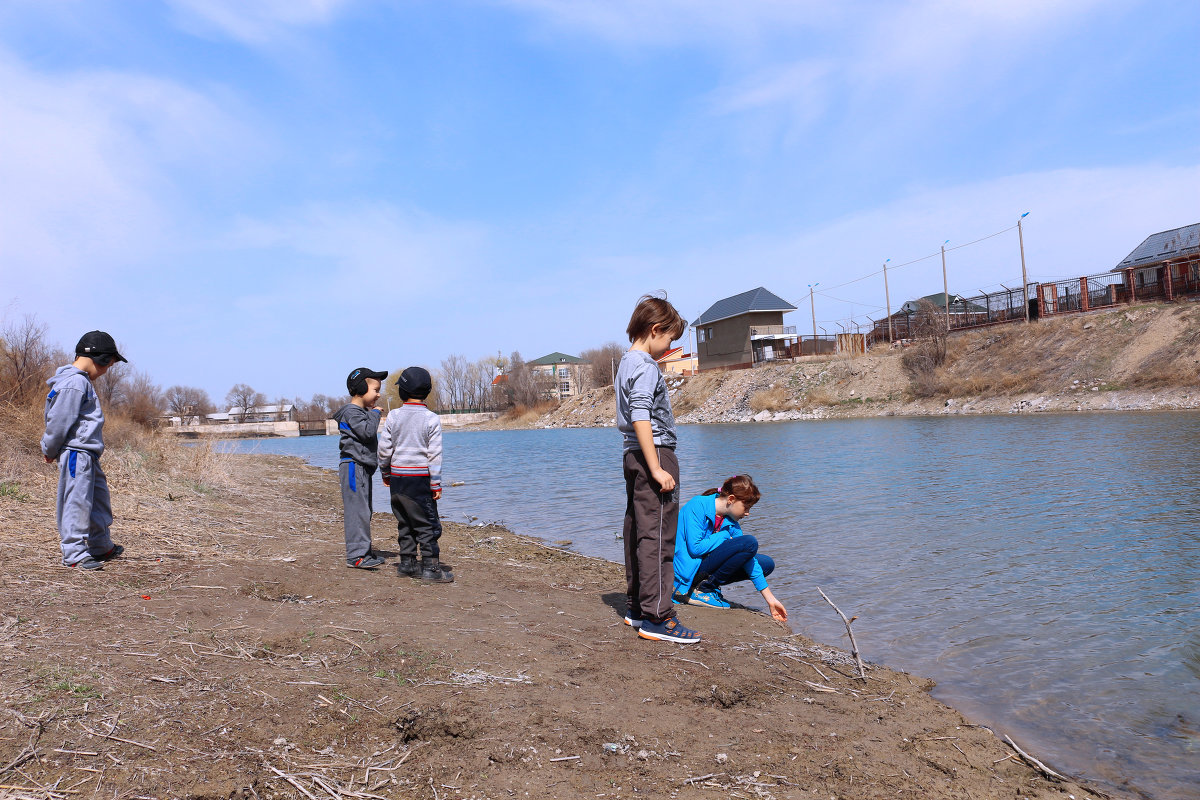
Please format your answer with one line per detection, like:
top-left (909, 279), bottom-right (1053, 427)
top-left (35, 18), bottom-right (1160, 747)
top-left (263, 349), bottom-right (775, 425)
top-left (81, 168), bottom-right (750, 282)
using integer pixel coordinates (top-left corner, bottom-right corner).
top-left (0, 0), bottom-right (1200, 401)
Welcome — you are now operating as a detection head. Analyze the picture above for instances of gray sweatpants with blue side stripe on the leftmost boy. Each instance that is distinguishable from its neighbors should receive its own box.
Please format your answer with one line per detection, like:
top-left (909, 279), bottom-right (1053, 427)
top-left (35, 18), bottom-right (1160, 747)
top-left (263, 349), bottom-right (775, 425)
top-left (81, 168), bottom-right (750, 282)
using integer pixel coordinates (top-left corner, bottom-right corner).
top-left (55, 450), bottom-right (113, 566)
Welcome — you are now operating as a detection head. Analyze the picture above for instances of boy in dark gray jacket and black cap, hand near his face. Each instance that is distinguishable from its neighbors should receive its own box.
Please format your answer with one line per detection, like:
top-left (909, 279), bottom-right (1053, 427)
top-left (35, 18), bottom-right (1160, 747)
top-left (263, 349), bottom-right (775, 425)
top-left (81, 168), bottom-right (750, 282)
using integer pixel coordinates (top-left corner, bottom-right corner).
top-left (334, 367), bottom-right (388, 570)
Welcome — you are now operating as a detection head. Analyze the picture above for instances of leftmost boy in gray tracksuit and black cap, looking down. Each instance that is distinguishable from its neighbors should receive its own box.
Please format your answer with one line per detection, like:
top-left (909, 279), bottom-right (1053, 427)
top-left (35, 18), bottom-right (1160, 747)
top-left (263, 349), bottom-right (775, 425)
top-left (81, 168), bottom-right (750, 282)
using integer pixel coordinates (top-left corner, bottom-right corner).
top-left (42, 331), bottom-right (126, 570)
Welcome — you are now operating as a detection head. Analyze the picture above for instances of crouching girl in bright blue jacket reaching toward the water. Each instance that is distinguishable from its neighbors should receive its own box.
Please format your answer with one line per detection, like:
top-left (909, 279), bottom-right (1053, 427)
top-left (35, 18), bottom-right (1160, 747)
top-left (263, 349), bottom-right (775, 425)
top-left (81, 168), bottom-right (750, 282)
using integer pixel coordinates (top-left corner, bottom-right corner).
top-left (674, 475), bottom-right (787, 622)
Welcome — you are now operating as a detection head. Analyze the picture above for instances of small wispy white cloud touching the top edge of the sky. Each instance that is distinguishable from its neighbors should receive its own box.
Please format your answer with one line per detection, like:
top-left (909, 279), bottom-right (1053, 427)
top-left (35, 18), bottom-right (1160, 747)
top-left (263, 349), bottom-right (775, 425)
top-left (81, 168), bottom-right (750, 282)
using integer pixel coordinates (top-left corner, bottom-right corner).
top-left (168, 0), bottom-right (353, 44)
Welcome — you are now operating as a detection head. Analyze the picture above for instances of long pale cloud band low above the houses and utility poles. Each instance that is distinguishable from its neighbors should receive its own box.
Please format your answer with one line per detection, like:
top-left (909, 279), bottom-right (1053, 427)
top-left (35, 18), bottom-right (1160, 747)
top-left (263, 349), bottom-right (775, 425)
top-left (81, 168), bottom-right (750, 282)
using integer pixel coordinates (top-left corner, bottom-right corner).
top-left (619, 166), bottom-right (1200, 329)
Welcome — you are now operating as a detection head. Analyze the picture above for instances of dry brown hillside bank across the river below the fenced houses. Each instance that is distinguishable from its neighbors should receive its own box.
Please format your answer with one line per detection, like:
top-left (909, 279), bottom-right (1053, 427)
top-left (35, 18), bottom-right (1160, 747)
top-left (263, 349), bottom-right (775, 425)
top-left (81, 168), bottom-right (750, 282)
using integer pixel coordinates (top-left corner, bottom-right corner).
top-left (520, 303), bottom-right (1200, 427)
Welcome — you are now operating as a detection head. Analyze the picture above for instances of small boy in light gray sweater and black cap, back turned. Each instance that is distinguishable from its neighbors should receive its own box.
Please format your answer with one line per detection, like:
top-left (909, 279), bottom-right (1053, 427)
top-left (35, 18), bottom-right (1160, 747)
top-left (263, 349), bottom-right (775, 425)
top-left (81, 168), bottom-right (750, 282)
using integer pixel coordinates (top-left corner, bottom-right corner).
top-left (379, 367), bottom-right (454, 583)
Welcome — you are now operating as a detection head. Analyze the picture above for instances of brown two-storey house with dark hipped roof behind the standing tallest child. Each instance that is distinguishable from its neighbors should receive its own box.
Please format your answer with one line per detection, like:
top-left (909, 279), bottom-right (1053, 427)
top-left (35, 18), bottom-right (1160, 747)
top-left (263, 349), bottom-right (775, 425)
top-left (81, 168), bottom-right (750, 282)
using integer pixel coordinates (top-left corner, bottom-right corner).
top-left (691, 287), bottom-right (798, 371)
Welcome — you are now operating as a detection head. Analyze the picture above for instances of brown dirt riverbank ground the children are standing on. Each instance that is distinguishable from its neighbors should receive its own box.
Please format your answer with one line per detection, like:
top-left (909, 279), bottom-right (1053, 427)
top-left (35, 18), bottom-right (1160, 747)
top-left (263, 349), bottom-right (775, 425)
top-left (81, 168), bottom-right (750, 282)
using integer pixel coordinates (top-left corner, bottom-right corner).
top-left (0, 456), bottom-right (1110, 800)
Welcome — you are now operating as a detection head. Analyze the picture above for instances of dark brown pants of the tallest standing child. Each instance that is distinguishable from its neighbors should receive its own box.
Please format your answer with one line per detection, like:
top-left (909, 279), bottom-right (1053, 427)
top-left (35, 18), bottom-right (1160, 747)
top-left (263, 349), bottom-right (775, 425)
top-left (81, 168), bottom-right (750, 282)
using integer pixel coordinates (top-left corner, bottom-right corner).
top-left (624, 447), bottom-right (679, 622)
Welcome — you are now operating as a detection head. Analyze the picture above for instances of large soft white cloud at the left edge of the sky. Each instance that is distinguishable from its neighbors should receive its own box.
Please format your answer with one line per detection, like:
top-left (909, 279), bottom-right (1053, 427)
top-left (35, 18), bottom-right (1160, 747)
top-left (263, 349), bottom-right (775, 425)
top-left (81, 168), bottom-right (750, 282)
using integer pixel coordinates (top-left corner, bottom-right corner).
top-left (0, 53), bottom-right (253, 291)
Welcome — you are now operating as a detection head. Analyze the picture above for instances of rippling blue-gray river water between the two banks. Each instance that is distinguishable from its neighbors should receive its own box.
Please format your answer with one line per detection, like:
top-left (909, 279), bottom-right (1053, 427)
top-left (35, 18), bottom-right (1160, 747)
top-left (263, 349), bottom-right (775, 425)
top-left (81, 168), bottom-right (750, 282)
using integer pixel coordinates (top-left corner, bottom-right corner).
top-left (220, 411), bottom-right (1200, 800)
